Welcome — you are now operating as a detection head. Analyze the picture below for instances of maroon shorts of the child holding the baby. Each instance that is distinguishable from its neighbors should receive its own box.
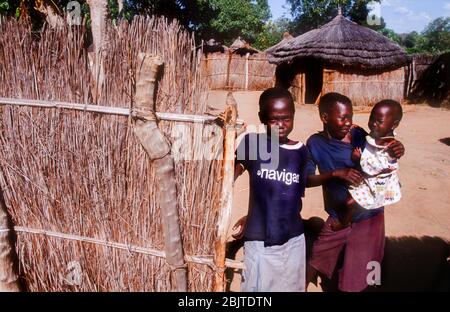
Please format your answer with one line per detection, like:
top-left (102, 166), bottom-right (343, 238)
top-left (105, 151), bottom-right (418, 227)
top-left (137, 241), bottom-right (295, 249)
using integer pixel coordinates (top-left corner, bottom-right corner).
top-left (309, 212), bottom-right (385, 292)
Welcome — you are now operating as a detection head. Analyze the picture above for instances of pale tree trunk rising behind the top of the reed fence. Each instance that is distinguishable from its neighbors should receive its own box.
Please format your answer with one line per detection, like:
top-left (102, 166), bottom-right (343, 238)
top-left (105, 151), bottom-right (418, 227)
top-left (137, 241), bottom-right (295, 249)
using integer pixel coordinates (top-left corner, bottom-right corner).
top-left (88, 0), bottom-right (108, 103)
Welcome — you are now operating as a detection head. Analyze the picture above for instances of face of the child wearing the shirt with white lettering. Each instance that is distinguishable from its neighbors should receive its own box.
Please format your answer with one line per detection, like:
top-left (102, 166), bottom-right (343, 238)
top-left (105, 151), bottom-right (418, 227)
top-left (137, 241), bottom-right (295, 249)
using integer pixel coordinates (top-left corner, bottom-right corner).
top-left (259, 98), bottom-right (294, 143)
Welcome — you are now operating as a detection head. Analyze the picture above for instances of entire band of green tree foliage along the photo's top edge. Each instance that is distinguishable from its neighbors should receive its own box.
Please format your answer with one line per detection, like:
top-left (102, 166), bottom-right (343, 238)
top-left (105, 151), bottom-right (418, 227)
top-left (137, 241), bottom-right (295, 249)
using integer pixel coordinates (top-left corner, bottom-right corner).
top-left (0, 0), bottom-right (450, 53)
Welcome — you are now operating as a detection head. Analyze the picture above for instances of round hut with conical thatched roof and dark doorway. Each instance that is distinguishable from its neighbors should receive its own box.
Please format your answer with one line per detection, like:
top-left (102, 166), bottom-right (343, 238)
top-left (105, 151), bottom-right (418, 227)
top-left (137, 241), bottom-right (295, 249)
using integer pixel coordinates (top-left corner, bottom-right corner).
top-left (266, 14), bottom-right (409, 105)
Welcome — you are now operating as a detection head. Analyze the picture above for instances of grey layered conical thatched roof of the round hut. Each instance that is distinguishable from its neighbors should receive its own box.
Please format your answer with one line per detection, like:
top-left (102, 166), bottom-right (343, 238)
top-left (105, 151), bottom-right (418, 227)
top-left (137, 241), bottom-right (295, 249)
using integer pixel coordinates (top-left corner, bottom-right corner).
top-left (268, 15), bottom-right (409, 69)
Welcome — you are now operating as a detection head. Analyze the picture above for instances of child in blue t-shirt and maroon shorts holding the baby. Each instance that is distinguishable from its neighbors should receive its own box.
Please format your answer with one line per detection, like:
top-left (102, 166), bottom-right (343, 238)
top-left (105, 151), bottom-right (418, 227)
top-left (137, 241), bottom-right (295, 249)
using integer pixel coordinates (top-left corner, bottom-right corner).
top-left (306, 93), bottom-right (405, 291)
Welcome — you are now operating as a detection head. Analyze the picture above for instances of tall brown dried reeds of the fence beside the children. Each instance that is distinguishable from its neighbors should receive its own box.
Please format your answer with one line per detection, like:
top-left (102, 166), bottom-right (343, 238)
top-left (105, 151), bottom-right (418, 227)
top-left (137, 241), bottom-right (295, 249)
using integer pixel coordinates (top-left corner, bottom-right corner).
top-left (0, 17), bottom-right (222, 291)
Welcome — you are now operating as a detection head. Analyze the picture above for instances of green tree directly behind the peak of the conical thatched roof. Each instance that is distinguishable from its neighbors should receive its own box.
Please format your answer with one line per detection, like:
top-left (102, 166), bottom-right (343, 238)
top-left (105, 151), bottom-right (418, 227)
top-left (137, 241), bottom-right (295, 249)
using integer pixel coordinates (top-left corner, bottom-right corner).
top-left (286, 0), bottom-right (380, 35)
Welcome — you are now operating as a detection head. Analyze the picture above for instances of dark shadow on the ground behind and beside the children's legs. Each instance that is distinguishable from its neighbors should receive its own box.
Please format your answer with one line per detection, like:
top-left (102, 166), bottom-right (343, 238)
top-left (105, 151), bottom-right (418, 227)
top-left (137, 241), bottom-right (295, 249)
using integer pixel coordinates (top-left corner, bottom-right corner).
top-left (226, 217), bottom-right (450, 292)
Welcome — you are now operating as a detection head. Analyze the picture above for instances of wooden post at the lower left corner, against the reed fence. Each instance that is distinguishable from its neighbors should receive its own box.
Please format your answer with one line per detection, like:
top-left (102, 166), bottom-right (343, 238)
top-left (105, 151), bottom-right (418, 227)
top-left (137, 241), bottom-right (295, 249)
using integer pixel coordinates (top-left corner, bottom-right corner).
top-left (0, 189), bottom-right (20, 292)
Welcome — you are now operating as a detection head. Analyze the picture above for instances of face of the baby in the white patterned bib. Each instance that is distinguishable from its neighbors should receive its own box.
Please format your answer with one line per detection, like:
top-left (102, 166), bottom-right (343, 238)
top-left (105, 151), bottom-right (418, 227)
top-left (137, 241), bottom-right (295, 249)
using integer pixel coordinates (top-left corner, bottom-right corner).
top-left (368, 106), bottom-right (398, 139)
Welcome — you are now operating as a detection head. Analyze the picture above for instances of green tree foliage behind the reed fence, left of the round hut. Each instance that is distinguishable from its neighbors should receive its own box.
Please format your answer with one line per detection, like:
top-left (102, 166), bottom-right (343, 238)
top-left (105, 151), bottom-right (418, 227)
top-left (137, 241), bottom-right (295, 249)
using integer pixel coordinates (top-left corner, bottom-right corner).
top-left (0, 0), bottom-right (271, 44)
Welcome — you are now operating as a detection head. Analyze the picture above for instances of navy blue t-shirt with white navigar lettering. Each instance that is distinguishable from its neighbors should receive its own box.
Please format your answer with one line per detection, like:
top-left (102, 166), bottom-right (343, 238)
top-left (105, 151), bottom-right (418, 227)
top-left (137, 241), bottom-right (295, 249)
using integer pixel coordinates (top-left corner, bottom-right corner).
top-left (236, 133), bottom-right (308, 246)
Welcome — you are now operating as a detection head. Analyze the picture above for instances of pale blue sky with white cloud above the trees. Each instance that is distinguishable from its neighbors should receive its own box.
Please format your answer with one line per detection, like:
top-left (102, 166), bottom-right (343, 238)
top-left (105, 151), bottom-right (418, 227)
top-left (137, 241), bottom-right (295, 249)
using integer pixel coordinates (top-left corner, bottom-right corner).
top-left (268, 0), bottom-right (450, 33)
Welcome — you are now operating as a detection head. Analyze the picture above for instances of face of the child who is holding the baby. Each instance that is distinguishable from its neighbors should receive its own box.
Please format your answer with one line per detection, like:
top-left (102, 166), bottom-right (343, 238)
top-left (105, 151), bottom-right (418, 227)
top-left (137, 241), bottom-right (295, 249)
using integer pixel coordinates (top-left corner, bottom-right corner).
top-left (321, 102), bottom-right (353, 140)
